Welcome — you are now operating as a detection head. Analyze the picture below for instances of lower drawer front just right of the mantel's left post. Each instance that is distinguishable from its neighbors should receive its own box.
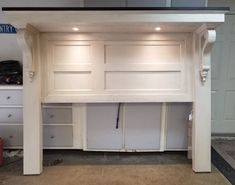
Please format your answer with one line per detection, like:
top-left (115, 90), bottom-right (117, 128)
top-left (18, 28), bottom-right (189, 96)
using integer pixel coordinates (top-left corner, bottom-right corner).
top-left (43, 126), bottom-right (73, 147)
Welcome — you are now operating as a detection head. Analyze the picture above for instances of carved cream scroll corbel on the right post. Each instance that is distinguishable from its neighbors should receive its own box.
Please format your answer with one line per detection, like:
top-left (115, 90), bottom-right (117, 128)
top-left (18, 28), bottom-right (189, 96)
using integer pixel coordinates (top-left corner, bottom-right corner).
top-left (200, 30), bottom-right (216, 84)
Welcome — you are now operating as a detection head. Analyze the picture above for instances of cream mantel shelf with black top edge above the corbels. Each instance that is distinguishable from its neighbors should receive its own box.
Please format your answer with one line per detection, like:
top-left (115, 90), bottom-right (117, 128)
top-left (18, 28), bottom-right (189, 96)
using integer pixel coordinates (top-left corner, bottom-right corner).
top-left (3, 8), bottom-right (229, 32)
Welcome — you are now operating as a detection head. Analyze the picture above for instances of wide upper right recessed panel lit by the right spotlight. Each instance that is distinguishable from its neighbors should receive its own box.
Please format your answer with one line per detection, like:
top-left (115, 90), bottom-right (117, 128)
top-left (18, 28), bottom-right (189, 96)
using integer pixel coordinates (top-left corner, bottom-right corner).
top-left (105, 42), bottom-right (181, 65)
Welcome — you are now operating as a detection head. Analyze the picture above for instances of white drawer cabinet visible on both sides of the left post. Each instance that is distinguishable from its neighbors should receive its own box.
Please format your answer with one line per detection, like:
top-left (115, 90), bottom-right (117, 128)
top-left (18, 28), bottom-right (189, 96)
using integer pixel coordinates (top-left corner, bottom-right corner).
top-left (0, 86), bottom-right (74, 149)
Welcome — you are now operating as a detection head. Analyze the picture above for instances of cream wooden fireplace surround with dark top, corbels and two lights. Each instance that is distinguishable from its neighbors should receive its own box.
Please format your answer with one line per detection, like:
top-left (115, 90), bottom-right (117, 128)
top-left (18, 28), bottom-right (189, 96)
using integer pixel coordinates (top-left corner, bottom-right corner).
top-left (3, 8), bottom-right (227, 175)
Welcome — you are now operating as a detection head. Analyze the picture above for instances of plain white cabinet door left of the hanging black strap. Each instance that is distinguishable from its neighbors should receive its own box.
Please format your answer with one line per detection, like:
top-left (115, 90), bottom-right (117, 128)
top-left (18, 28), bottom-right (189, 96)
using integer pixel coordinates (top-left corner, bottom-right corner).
top-left (87, 104), bottom-right (123, 150)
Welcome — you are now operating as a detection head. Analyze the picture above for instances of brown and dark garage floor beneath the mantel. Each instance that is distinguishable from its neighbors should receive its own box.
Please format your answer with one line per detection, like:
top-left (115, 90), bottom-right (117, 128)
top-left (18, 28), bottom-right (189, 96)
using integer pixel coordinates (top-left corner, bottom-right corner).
top-left (0, 151), bottom-right (230, 185)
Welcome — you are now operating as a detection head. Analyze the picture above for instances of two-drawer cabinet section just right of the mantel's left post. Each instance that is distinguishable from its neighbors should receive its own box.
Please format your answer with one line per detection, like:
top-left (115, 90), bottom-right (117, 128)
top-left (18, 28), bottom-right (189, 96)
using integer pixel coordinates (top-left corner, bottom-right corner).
top-left (42, 104), bottom-right (74, 149)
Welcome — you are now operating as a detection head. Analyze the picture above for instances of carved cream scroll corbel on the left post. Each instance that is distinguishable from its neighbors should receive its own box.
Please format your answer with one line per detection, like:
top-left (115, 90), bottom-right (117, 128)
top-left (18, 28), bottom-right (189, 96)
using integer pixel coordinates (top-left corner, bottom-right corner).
top-left (17, 25), bottom-right (37, 82)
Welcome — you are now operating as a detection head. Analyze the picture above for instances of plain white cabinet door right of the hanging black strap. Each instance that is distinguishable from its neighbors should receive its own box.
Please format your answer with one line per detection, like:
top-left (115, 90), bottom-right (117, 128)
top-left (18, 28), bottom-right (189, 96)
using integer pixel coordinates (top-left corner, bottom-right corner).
top-left (125, 103), bottom-right (161, 151)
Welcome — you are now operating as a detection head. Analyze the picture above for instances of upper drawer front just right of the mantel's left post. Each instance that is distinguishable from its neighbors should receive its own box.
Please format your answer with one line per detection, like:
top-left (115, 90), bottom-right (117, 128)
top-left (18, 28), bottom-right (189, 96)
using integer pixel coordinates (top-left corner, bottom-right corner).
top-left (43, 108), bottom-right (72, 124)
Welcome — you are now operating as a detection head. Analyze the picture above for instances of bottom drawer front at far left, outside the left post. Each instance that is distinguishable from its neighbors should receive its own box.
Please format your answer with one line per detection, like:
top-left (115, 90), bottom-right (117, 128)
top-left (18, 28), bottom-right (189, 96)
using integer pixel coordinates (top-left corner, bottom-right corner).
top-left (0, 125), bottom-right (23, 147)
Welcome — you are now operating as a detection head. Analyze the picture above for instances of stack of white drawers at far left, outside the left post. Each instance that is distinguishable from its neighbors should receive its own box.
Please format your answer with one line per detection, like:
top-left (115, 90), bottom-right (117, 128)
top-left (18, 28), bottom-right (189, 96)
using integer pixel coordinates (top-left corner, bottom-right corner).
top-left (0, 86), bottom-right (23, 148)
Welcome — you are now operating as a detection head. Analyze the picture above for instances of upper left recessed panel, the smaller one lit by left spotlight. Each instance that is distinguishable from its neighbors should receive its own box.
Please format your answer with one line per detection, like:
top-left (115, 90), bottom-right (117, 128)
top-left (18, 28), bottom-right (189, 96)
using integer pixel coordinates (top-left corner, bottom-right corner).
top-left (53, 42), bottom-right (91, 65)
